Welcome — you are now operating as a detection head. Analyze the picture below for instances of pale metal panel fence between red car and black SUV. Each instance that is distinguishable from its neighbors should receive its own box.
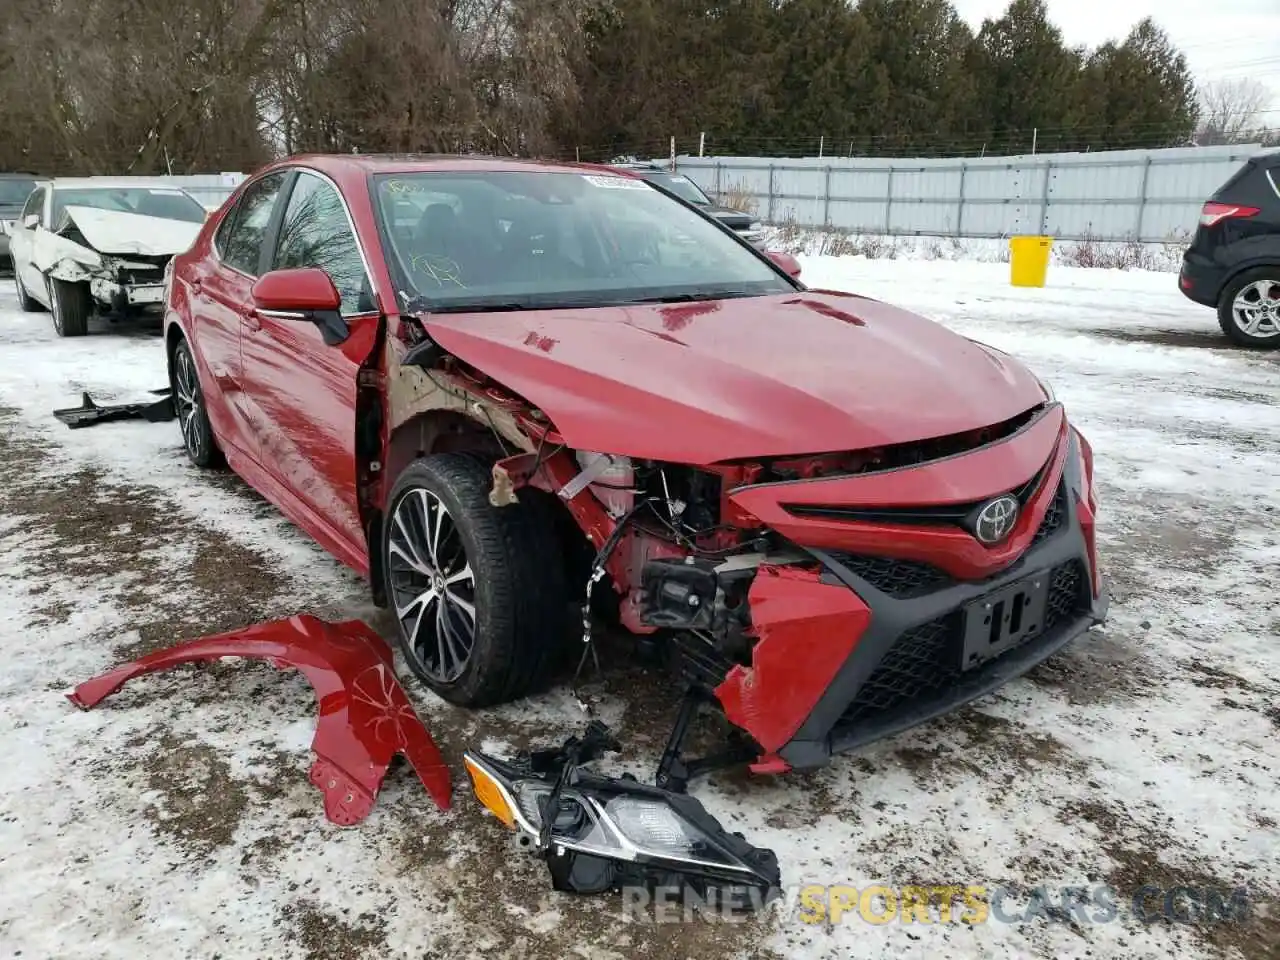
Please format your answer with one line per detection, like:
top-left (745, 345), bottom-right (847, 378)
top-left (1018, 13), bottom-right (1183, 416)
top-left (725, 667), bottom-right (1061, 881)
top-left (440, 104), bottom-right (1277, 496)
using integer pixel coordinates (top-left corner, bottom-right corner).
top-left (676, 145), bottom-right (1266, 242)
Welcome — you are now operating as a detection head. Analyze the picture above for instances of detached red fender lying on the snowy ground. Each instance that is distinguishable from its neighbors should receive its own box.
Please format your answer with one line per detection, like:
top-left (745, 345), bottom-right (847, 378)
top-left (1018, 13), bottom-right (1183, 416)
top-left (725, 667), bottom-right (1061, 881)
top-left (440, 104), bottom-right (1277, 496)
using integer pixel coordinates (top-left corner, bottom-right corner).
top-left (67, 616), bottom-right (452, 827)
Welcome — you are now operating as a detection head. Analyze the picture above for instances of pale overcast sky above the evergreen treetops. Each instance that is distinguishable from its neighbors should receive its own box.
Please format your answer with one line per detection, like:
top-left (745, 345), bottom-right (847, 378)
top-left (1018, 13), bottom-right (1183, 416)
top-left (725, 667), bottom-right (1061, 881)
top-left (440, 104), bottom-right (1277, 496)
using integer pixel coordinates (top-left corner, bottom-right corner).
top-left (951, 0), bottom-right (1280, 119)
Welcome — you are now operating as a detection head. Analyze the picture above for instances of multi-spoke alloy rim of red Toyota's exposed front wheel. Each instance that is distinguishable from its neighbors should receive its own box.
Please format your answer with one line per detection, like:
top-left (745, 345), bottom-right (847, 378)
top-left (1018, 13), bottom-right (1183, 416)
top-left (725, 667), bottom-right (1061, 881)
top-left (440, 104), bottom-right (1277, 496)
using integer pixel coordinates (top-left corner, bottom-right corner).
top-left (387, 486), bottom-right (476, 684)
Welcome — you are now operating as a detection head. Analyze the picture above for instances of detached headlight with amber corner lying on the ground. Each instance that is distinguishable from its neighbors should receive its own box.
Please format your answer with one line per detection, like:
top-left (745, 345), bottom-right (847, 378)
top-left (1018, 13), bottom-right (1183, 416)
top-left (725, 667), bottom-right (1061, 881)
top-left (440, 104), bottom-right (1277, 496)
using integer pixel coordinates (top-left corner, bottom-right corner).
top-left (463, 722), bottom-right (781, 913)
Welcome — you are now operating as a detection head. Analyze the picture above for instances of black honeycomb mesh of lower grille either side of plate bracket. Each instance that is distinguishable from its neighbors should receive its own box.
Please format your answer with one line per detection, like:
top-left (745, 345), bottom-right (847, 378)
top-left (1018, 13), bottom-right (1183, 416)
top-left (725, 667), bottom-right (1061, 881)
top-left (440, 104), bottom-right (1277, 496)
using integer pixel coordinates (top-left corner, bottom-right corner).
top-left (840, 561), bottom-right (1084, 724)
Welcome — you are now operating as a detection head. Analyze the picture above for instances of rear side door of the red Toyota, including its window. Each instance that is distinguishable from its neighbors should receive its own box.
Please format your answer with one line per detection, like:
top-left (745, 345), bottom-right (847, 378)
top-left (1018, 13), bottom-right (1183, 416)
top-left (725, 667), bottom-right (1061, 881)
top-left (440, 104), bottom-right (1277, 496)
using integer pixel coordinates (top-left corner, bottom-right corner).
top-left (184, 172), bottom-right (289, 460)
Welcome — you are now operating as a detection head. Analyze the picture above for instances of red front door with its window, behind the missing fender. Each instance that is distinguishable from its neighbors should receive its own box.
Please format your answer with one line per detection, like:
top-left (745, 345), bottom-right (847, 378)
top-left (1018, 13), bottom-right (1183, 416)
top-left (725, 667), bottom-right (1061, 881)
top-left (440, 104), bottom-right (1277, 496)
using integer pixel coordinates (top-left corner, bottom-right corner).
top-left (241, 170), bottom-right (379, 571)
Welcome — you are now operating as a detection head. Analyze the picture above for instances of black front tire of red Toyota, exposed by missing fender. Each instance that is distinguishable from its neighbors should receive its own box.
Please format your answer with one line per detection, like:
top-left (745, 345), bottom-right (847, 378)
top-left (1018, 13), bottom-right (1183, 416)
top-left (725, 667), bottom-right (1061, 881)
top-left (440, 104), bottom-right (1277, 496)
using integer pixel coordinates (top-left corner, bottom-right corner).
top-left (380, 453), bottom-right (572, 707)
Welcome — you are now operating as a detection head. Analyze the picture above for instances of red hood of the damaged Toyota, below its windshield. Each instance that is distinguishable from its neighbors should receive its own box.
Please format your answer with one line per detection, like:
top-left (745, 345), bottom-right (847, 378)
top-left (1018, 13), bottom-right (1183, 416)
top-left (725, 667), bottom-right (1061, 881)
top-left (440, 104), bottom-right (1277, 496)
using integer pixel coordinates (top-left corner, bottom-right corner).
top-left (425, 292), bottom-right (1044, 463)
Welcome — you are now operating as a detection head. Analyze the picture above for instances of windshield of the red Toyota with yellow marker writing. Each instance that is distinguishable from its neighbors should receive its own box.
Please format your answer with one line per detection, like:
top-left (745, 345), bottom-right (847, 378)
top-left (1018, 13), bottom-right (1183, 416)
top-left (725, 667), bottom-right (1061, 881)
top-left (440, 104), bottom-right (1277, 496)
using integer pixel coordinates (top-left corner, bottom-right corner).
top-left (374, 170), bottom-right (795, 311)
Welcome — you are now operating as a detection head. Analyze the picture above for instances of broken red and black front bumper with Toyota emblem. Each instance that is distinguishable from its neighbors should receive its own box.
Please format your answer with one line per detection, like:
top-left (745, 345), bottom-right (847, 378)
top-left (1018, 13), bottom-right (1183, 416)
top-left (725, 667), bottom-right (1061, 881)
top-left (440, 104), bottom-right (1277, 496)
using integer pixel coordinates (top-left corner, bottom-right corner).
top-left (716, 404), bottom-right (1107, 768)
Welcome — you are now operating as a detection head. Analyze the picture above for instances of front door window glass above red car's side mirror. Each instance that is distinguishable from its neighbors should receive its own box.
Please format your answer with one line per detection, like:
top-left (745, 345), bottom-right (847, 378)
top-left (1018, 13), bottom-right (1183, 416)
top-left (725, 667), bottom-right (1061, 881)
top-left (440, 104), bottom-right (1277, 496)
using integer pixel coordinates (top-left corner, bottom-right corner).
top-left (273, 173), bottom-right (374, 314)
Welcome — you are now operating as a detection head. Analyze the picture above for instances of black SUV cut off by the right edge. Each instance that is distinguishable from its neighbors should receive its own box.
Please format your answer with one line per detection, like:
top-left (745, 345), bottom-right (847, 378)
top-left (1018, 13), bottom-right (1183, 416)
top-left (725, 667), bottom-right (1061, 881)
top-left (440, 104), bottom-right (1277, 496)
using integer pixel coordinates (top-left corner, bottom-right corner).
top-left (1178, 152), bottom-right (1280, 348)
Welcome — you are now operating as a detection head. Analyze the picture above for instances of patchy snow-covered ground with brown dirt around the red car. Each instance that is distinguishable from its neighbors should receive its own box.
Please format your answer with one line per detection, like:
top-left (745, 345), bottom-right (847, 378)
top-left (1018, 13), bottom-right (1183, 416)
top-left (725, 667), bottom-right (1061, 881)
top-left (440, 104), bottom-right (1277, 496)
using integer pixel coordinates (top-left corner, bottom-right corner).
top-left (0, 257), bottom-right (1280, 960)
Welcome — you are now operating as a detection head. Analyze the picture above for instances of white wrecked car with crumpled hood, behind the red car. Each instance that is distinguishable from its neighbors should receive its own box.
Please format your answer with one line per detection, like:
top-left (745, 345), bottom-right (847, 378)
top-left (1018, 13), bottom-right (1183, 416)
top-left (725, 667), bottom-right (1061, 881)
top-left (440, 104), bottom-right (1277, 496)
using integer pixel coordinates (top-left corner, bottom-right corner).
top-left (9, 177), bottom-right (207, 337)
